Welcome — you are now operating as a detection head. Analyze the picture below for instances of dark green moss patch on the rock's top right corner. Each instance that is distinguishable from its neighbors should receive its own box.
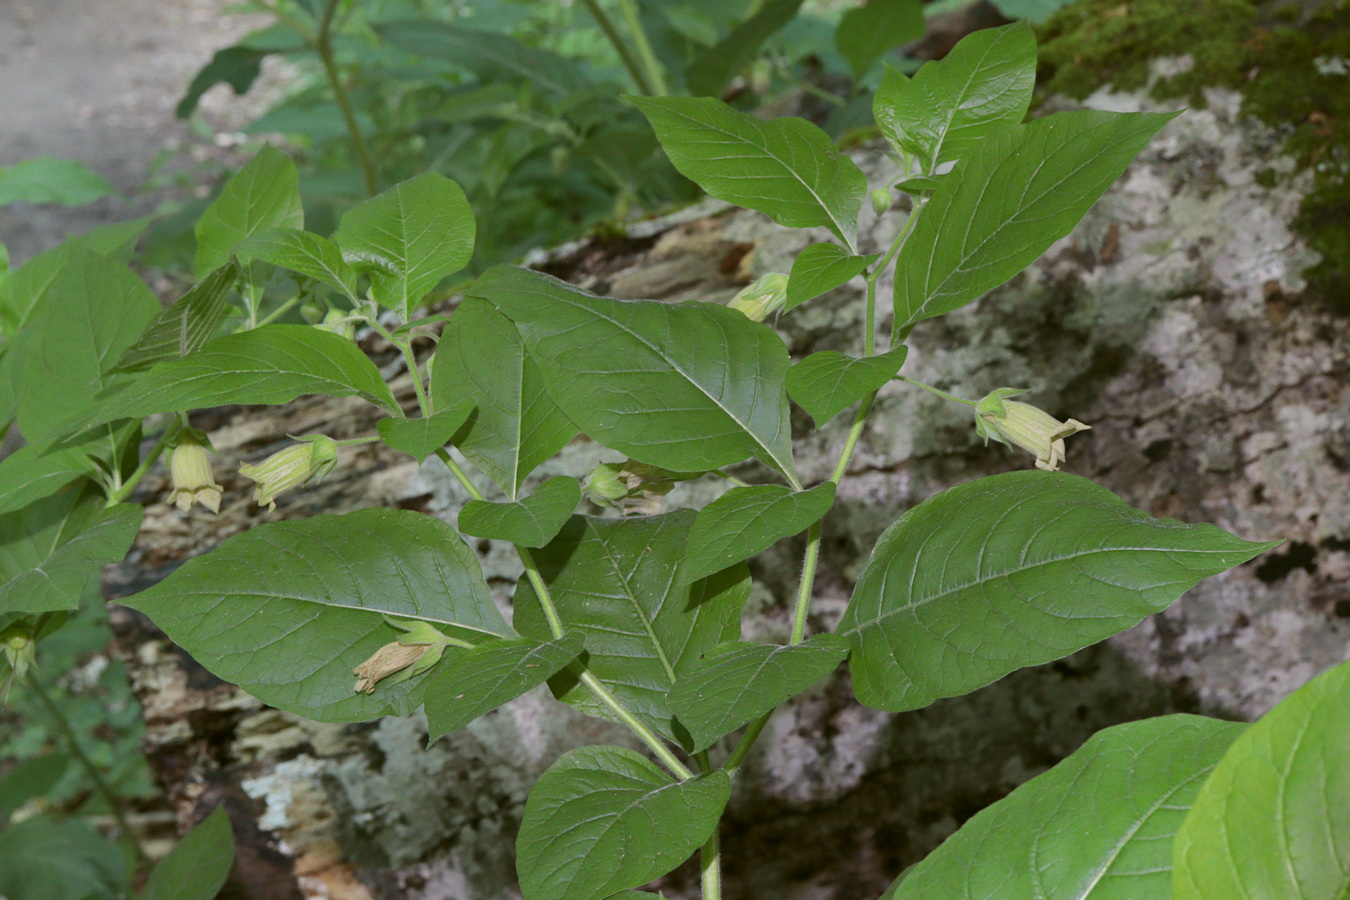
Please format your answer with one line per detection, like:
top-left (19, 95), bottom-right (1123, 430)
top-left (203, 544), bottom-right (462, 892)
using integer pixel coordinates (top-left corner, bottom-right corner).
top-left (1041, 0), bottom-right (1350, 312)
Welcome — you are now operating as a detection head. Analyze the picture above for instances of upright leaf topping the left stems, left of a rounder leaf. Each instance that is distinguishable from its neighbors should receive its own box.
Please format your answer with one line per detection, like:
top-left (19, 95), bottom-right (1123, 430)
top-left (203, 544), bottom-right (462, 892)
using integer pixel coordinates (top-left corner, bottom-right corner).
top-left (196, 144), bottom-right (305, 277)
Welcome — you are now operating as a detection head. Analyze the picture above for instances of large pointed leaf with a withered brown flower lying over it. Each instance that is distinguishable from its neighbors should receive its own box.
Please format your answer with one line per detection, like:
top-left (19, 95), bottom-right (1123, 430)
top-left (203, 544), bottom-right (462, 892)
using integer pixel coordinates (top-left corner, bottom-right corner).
top-left (120, 509), bottom-right (516, 722)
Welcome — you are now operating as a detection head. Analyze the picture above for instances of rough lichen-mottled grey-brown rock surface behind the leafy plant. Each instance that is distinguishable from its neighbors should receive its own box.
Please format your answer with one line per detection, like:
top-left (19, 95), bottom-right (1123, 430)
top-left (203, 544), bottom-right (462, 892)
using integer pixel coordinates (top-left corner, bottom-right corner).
top-left (108, 82), bottom-right (1350, 900)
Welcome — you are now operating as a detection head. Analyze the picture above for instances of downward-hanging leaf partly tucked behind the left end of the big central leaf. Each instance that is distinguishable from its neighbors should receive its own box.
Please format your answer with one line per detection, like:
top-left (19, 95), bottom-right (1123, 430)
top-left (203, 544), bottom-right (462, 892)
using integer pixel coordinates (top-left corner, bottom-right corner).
top-left (431, 297), bottom-right (576, 499)
